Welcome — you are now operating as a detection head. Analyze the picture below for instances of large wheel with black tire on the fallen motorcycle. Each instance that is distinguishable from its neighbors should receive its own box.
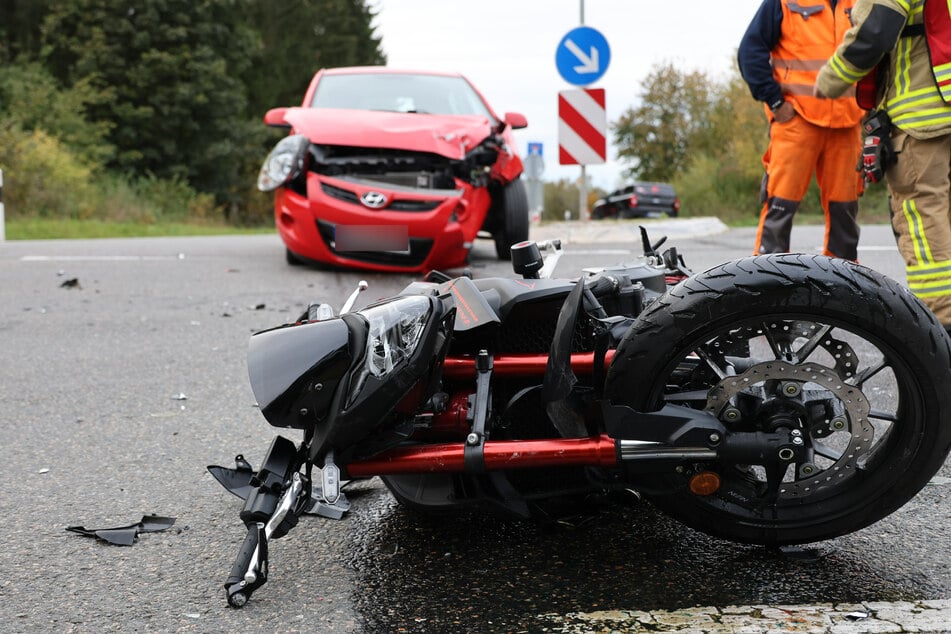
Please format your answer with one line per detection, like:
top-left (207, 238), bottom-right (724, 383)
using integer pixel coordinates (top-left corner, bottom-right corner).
top-left (605, 254), bottom-right (951, 546)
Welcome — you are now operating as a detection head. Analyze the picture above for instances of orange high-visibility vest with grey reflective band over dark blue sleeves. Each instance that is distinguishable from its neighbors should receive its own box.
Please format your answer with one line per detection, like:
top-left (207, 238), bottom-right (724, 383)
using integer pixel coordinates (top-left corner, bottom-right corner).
top-left (770, 0), bottom-right (864, 128)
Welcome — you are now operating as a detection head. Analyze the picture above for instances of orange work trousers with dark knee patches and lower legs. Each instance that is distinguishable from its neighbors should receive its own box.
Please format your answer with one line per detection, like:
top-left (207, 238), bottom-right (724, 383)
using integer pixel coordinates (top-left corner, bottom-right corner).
top-left (753, 116), bottom-right (863, 261)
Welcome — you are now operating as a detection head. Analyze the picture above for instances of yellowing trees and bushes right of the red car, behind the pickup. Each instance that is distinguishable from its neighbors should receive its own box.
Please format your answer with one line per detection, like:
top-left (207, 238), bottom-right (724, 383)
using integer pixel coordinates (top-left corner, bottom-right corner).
top-left (543, 64), bottom-right (889, 226)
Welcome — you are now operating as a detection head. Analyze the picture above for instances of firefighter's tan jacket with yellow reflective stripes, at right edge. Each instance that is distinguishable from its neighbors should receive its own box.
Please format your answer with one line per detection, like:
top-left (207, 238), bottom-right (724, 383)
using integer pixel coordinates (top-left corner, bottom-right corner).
top-left (816, 0), bottom-right (951, 139)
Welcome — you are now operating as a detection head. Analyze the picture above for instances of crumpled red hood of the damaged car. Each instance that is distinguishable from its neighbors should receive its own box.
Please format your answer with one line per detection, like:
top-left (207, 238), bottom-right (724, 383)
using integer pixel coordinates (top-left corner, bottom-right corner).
top-left (284, 108), bottom-right (492, 159)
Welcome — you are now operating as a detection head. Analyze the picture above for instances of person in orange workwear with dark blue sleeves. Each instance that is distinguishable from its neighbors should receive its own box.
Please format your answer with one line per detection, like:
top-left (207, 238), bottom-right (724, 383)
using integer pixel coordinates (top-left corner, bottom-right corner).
top-left (738, 0), bottom-right (864, 260)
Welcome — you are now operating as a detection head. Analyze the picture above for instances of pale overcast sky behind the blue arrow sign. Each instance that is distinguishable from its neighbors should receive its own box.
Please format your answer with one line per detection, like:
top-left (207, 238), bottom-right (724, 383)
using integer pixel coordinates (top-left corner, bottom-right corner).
top-left (368, 0), bottom-right (761, 189)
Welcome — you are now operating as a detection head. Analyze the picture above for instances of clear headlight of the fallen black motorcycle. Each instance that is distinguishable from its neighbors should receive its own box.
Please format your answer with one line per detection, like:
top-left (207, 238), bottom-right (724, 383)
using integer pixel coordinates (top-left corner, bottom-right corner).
top-left (348, 295), bottom-right (432, 405)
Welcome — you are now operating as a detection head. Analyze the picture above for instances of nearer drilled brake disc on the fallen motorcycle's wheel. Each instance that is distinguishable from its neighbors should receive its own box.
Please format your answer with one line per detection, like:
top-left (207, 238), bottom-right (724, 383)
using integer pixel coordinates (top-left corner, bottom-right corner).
top-left (704, 361), bottom-right (875, 498)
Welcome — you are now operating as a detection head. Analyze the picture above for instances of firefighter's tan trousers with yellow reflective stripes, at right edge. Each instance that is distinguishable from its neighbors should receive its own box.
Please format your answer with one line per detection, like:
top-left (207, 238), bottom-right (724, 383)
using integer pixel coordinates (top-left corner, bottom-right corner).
top-left (885, 129), bottom-right (951, 326)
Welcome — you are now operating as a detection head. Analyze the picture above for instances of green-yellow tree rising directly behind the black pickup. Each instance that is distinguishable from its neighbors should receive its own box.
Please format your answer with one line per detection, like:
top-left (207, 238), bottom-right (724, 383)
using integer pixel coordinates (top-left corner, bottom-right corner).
top-left (611, 63), bottom-right (715, 181)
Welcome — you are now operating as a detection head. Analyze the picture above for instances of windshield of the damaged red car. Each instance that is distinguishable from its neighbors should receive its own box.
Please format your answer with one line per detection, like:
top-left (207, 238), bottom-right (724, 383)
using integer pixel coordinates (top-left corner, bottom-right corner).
top-left (310, 73), bottom-right (493, 119)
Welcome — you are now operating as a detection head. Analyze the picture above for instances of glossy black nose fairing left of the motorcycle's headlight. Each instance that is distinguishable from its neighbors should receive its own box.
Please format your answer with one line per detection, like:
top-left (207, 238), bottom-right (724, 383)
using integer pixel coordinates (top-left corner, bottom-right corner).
top-left (248, 319), bottom-right (353, 429)
